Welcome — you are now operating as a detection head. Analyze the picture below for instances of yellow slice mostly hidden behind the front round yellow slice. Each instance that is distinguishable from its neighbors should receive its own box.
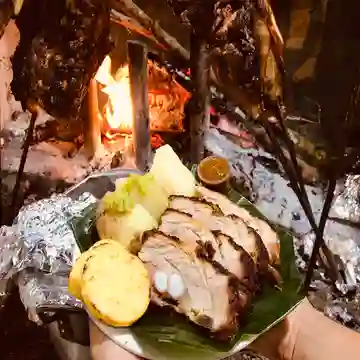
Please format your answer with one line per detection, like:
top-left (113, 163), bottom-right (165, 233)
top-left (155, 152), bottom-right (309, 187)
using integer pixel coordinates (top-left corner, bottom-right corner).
top-left (68, 240), bottom-right (118, 300)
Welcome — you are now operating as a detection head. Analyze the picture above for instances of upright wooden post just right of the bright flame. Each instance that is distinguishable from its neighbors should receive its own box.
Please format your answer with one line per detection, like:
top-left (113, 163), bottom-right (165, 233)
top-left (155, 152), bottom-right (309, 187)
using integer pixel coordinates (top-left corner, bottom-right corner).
top-left (127, 41), bottom-right (151, 171)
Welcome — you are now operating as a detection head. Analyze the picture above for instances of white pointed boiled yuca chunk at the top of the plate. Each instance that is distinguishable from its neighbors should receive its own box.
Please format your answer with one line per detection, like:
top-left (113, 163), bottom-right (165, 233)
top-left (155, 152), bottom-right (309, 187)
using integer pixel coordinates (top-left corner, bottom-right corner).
top-left (150, 145), bottom-right (195, 196)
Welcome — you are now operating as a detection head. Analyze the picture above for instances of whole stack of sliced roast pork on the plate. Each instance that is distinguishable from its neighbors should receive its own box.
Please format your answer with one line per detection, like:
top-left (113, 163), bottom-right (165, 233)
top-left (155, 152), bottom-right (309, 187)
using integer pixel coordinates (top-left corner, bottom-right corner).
top-left (138, 187), bottom-right (278, 339)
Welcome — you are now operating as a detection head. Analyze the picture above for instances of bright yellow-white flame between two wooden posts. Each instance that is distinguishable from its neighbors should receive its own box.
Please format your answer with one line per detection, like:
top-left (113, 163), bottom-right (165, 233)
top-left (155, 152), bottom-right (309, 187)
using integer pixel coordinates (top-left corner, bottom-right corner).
top-left (95, 56), bottom-right (133, 130)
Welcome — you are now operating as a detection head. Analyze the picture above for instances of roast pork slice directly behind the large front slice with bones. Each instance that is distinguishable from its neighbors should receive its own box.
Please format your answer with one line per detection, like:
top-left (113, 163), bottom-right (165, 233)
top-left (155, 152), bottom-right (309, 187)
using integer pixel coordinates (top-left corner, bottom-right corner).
top-left (159, 208), bottom-right (256, 291)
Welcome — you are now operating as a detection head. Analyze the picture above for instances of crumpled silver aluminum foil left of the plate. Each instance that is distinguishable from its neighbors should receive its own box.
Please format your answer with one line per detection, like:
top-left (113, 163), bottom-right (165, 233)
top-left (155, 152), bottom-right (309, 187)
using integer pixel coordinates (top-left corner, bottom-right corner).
top-left (0, 193), bottom-right (97, 321)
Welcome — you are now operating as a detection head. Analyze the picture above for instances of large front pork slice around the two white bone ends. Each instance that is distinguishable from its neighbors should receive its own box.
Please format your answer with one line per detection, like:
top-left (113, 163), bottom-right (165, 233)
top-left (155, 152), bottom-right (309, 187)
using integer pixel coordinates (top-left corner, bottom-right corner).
top-left (139, 231), bottom-right (251, 338)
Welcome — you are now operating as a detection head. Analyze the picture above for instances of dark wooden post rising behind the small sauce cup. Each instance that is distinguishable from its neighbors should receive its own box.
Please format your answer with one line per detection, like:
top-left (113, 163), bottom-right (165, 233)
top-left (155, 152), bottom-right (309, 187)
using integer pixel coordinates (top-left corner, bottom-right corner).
top-left (190, 33), bottom-right (211, 164)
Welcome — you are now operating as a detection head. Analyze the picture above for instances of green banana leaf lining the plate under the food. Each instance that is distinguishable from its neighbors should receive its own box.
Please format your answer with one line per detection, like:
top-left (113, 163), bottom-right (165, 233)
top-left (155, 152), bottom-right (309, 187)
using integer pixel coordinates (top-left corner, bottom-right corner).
top-left (70, 169), bottom-right (303, 360)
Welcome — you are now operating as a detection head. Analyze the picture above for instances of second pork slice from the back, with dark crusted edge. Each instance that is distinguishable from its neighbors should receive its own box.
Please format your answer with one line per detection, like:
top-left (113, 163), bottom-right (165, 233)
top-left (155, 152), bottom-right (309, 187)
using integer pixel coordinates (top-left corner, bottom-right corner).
top-left (169, 196), bottom-right (269, 272)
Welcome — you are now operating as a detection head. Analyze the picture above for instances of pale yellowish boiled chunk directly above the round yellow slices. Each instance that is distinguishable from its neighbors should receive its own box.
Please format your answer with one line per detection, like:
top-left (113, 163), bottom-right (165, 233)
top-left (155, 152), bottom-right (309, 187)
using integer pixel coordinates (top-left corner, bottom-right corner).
top-left (96, 204), bottom-right (157, 253)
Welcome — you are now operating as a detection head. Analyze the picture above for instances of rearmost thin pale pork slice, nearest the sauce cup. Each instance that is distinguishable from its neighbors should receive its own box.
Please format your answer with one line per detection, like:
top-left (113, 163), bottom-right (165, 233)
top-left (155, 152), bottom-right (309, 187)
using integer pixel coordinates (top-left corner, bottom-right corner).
top-left (197, 186), bottom-right (280, 264)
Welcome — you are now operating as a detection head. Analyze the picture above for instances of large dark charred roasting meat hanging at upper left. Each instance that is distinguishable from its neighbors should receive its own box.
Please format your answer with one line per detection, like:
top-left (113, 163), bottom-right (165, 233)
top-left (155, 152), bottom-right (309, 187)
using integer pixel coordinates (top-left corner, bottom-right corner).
top-left (11, 0), bottom-right (111, 118)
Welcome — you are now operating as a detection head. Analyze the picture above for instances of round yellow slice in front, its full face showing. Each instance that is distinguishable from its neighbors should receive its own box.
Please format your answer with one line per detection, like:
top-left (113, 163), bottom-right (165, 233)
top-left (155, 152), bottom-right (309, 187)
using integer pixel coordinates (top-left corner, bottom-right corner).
top-left (81, 245), bottom-right (150, 327)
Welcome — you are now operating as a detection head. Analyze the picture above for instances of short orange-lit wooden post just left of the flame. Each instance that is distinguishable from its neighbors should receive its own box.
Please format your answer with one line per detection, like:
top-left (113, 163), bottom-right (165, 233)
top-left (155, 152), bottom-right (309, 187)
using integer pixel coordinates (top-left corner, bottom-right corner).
top-left (84, 79), bottom-right (101, 159)
